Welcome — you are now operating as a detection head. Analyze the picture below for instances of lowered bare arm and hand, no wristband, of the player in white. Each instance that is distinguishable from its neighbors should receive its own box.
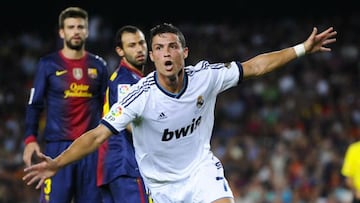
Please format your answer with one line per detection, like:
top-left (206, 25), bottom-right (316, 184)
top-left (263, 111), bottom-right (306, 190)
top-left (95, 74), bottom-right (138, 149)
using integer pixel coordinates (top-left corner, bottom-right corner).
top-left (23, 124), bottom-right (112, 189)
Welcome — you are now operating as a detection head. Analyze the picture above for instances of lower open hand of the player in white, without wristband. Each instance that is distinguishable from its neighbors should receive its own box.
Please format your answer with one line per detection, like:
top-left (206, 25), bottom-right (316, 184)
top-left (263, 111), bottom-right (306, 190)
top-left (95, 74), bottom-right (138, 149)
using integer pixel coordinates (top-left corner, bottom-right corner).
top-left (23, 153), bottom-right (59, 189)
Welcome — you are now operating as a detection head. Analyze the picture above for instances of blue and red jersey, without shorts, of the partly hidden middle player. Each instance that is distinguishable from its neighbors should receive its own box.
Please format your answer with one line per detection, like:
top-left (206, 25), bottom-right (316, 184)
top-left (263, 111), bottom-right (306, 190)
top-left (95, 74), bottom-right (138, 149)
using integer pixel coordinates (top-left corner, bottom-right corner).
top-left (97, 61), bottom-right (143, 186)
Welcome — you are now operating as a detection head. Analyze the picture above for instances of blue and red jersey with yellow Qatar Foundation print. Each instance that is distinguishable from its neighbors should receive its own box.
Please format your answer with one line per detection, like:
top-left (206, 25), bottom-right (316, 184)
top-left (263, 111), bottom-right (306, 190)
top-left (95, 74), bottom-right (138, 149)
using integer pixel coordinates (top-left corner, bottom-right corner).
top-left (25, 51), bottom-right (109, 142)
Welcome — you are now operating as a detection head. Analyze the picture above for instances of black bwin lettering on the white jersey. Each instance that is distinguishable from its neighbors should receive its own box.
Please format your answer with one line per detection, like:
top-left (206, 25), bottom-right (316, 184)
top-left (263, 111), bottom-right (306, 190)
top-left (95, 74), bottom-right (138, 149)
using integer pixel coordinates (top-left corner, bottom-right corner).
top-left (161, 116), bottom-right (201, 142)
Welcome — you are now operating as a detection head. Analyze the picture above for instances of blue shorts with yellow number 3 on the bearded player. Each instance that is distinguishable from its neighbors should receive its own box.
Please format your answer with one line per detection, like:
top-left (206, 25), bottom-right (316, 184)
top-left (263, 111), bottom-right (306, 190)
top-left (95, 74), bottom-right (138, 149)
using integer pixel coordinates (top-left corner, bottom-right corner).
top-left (40, 141), bottom-right (101, 203)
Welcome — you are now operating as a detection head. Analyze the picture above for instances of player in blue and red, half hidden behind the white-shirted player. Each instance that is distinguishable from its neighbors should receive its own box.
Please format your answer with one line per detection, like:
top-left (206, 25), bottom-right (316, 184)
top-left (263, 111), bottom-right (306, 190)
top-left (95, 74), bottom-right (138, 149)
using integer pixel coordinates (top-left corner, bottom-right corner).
top-left (97, 25), bottom-right (148, 203)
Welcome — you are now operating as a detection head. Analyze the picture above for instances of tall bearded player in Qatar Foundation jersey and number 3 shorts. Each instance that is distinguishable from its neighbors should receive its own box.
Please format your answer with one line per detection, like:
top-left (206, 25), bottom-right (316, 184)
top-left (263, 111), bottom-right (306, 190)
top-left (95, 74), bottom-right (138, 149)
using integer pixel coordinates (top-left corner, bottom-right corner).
top-left (23, 7), bottom-right (108, 203)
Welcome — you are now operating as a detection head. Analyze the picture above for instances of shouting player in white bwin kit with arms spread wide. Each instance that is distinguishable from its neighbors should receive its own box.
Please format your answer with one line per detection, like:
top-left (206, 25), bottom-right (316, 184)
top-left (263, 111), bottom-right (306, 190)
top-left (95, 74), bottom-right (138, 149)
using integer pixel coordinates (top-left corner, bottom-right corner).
top-left (23, 23), bottom-right (337, 203)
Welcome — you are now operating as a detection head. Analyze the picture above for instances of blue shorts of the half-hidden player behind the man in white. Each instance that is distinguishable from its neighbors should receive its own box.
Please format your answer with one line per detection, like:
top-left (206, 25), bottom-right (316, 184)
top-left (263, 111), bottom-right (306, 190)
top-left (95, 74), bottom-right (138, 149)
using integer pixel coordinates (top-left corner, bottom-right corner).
top-left (100, 176), bottom-right (152, 203)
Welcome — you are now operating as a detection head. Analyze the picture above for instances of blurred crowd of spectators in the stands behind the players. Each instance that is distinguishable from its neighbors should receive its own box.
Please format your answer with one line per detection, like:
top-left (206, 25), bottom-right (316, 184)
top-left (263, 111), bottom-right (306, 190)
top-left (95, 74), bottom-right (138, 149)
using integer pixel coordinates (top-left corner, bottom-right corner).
top-left (0, 12), bottom-right (360, 203)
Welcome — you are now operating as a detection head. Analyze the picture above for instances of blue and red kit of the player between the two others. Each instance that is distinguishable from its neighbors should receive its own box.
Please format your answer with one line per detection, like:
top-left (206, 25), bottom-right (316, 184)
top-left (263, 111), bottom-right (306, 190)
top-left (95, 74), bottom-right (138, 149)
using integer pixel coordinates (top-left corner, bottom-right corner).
top-left (97, 60), bottom-right (148, 203)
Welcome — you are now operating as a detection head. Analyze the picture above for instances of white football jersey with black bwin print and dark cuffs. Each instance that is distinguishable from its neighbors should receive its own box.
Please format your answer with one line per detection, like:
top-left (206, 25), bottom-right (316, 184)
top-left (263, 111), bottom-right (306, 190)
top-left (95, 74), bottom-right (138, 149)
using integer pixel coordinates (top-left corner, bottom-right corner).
top-left (102, 61), bottom-right (243, 187)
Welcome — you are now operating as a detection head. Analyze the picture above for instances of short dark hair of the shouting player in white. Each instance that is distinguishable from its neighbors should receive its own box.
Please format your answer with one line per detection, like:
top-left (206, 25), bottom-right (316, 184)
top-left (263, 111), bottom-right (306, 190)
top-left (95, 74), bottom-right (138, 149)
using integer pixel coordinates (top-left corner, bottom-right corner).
top-left (149, 23), bottom-right (186, 51)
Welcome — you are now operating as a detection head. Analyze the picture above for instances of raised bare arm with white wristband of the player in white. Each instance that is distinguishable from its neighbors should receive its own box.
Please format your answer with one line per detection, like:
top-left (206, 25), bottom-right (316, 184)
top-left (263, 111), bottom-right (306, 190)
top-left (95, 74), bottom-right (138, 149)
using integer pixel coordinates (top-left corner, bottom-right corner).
top-left (242, 27), bottom-right (337, 78)
